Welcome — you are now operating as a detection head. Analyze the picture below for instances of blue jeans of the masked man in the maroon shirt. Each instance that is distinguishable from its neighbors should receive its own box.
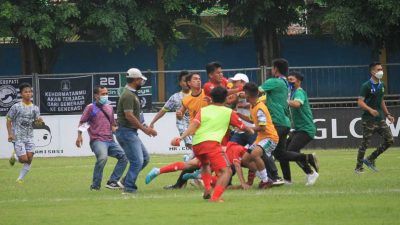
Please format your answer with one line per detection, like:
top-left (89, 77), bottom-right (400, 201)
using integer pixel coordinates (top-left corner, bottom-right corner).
top-left (90, 140), bottom-right (128, 188)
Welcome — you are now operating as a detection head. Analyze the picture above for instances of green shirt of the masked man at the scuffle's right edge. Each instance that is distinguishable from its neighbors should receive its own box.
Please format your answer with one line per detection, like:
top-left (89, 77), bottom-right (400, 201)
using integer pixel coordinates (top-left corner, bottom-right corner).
top-left (291, 88), bottom-right (317, 138)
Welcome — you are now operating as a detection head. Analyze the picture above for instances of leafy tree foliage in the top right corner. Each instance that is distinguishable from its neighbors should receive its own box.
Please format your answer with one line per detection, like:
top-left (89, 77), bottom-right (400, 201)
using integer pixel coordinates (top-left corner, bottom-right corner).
top-left (324, 0), bottom-right (400, 51)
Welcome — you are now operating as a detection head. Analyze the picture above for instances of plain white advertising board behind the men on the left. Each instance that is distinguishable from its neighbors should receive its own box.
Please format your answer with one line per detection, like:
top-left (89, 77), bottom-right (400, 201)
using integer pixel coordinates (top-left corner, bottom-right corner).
top-left (0, 113), bottom-right (189, 158)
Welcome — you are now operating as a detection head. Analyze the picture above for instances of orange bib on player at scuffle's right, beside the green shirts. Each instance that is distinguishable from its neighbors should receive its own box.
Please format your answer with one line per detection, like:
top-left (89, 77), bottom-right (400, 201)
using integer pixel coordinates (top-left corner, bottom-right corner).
top-left (250, 101), bottom-right (279, 143)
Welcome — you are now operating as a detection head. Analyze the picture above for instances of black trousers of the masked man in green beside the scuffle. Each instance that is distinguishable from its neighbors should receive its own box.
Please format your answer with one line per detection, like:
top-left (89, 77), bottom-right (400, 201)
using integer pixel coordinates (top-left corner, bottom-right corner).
top-left (286, 131), bottom-right (312, 177)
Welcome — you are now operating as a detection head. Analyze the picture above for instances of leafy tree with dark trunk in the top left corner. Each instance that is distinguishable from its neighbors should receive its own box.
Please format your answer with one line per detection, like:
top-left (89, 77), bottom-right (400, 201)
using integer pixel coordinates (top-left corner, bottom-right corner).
top-left (0, 0), bottom-right (79, 74)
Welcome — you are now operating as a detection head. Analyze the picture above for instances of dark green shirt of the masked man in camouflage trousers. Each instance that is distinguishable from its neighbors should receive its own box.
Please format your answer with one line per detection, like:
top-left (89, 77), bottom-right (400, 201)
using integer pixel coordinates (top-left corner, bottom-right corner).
top-left (360, 80), bottom-right (385, 121)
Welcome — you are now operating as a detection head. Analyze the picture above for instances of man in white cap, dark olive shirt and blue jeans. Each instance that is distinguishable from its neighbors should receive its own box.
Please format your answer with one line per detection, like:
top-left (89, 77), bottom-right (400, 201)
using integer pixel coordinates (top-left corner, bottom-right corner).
top-left (116, 68), bottom-right (157, 194)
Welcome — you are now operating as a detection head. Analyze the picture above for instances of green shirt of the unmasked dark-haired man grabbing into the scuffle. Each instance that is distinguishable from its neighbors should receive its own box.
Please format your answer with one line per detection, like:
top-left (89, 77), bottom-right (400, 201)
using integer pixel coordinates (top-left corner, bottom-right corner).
top-left (260, 77), bottom-right (290, 127)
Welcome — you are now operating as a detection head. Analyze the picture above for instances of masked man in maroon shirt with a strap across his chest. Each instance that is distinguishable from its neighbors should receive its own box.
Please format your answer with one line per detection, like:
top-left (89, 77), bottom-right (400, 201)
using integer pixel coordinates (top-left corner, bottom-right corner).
top-left (76, 86), bottom-right (128, 190)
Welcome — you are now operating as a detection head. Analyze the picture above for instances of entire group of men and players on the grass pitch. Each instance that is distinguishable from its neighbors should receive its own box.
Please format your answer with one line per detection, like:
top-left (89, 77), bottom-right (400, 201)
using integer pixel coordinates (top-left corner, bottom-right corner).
top-left (7, 59), bottom-right (394, 202)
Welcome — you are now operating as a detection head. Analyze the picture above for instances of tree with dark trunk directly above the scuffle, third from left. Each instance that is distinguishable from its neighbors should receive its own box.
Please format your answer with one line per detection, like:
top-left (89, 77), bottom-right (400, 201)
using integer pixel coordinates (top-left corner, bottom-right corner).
top-left (218, 0), bottom-right (305, 66)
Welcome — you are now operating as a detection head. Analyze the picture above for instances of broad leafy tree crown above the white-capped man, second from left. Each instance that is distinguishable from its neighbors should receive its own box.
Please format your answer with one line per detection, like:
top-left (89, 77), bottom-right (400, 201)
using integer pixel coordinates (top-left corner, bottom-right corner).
top-left (77, 0), bottom-right (212, 63)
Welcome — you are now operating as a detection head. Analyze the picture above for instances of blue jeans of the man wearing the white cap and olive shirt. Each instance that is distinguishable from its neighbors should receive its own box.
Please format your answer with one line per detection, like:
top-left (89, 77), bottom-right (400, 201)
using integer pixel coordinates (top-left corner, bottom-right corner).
top-left (115, 127), bottom-right (150, 192)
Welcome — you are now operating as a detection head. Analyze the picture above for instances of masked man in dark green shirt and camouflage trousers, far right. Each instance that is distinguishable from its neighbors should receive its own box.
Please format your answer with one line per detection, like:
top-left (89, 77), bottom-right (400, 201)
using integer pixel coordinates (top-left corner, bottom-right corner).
top-left (355, 62), bottom-right (394, 173)
